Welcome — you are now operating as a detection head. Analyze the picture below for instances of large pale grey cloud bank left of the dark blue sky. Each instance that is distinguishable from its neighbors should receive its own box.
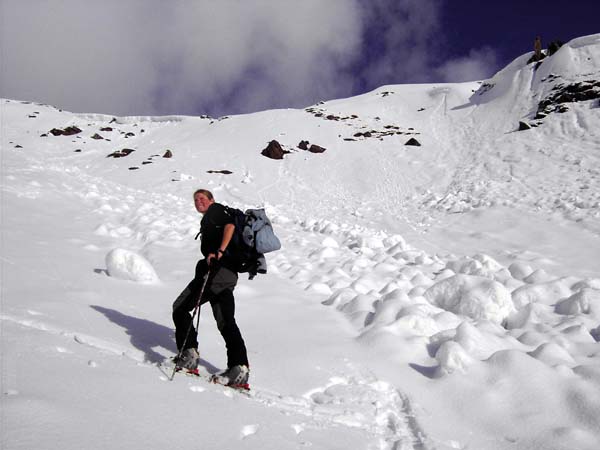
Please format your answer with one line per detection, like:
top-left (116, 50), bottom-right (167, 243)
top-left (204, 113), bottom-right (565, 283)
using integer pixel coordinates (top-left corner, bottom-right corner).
top-left (0, 0), bottom-right (361, 114)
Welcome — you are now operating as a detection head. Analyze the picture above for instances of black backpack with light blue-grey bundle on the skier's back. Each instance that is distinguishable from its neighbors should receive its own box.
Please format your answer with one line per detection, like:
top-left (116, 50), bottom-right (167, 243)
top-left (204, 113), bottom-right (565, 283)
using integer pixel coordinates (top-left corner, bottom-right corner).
top-left (225, 206), bottom-right (281, 280)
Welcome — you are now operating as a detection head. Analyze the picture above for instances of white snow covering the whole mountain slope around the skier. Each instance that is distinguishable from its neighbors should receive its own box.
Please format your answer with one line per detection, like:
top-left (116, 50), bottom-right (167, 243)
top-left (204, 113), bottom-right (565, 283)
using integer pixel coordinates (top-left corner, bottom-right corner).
top-left (0, 35), bottom-right (600, 450)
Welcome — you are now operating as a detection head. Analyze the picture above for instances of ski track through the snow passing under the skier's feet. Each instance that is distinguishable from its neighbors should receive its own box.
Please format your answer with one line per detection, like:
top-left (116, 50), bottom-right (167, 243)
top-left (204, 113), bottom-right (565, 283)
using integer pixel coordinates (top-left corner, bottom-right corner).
top-left (0, 314), bottom-right (430, 450)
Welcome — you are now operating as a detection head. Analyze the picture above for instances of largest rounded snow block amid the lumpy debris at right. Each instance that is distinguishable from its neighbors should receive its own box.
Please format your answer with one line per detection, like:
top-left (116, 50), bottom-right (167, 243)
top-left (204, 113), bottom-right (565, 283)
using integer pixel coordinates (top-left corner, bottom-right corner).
top-left (425, 275), bottom-right (515, 323)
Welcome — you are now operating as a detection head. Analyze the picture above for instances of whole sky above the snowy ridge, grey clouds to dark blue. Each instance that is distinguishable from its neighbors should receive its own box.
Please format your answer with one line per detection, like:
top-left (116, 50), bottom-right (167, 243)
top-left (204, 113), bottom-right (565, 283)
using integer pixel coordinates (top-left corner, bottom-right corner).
top-left (0, 0), bottom-right (600, 117)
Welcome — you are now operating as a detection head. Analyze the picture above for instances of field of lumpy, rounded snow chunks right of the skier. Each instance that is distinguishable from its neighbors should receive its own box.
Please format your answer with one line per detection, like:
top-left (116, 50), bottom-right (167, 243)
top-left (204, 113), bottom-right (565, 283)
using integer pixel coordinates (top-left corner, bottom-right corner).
top-left (273, 216), bottom-right (600, 382)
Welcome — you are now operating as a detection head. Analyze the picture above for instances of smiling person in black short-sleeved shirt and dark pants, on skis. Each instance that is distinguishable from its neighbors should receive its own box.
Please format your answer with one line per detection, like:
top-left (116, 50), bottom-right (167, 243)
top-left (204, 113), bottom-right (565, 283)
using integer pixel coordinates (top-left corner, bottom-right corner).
top-left (173, 189), bottom-right (250, 387)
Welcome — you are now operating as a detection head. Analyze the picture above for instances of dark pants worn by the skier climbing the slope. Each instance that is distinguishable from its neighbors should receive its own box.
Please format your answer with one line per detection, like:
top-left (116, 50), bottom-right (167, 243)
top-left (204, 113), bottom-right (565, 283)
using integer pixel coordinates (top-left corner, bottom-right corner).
top-left (173, 259), bottom-right (248, 367)
